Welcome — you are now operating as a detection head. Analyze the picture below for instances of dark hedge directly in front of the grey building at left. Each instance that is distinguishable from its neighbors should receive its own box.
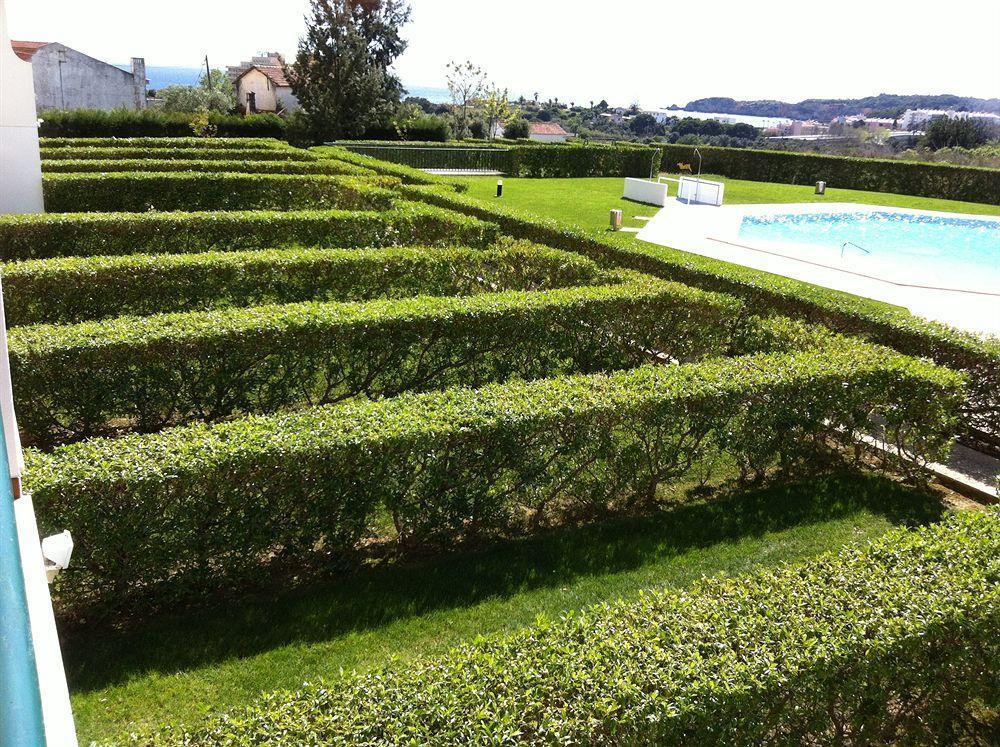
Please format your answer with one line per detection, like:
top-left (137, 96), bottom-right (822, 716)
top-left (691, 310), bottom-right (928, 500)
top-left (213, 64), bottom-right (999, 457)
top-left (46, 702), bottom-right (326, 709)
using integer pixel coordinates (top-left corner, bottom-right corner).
top-left (38, 109), bottom-right (285, 138)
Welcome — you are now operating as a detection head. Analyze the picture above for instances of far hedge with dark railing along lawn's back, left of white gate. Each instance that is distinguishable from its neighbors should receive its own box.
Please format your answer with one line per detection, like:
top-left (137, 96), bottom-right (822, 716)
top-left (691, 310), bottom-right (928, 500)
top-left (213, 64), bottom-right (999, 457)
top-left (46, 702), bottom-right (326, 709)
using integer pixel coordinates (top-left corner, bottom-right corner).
top-left (339, 142), bottom-right (661, 178)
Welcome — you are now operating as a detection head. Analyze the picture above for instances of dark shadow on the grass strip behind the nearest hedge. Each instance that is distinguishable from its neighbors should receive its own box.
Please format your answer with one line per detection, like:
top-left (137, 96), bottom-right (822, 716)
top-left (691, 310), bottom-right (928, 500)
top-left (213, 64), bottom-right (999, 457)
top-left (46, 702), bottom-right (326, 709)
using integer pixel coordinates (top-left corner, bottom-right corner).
top-left (63, 472), bottom-right (942, 692)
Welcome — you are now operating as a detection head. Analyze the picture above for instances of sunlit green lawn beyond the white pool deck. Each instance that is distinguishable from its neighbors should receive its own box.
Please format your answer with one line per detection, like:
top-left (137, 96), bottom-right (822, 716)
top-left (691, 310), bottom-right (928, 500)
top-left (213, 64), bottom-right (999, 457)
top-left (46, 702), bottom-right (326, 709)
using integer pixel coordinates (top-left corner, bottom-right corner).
top-left (461, 174), bottom-right (1000, 228)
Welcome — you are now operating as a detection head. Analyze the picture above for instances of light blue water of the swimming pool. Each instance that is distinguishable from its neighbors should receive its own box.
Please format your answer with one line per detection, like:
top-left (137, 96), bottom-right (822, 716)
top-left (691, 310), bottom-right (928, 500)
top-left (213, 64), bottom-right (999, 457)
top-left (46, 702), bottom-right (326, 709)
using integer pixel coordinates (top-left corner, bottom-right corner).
top-left (739, 211), bottom-right (1000, 293)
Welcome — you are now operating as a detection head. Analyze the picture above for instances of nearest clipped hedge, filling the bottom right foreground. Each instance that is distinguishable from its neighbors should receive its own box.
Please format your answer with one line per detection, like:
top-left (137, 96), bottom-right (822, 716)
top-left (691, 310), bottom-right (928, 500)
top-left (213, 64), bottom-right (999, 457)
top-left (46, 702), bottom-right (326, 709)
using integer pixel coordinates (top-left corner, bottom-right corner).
top-left (150, 513), bottom-right (1000, 747)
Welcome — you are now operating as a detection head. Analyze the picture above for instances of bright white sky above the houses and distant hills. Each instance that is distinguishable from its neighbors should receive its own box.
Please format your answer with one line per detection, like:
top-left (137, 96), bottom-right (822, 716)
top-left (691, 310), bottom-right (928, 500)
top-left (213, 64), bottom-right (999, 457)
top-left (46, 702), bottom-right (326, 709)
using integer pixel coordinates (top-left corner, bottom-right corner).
top-left (7, 0), bottom-right (1000, 107)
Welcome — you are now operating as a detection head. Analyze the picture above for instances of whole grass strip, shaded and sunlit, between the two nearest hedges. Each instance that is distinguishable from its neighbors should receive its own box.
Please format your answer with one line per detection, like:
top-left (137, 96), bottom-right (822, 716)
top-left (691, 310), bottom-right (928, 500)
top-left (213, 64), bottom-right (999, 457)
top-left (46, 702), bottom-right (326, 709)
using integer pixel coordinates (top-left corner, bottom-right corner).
top-left (64, 472), bottom-right (941, 743)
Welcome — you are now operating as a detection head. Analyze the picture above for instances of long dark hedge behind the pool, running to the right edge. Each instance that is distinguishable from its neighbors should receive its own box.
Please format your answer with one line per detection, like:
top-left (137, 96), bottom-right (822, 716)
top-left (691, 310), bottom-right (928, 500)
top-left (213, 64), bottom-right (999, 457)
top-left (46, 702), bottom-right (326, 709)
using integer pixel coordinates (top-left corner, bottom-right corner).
top-left (659, 145), bottom-right (1000, 205)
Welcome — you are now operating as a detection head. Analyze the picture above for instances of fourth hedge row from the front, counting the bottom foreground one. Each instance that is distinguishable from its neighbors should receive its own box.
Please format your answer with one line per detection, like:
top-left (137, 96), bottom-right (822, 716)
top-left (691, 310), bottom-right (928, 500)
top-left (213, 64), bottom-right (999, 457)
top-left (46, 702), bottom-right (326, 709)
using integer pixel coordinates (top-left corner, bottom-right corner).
top-left (0, 243), bottom-right (601, 327)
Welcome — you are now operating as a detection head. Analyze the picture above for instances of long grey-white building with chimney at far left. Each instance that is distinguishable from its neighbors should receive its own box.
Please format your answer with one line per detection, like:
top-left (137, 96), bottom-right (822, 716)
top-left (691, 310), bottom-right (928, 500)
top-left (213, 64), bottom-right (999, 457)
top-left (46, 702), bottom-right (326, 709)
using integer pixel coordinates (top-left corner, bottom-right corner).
top-left (11, 41), bottom-right (147, 112)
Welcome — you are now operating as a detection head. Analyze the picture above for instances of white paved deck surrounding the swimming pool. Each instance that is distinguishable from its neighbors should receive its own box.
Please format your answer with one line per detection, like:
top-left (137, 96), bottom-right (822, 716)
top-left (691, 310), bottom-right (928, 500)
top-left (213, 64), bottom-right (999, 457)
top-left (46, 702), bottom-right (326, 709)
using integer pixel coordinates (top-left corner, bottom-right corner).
top-left (638, 201), bottom-right (1000, 336)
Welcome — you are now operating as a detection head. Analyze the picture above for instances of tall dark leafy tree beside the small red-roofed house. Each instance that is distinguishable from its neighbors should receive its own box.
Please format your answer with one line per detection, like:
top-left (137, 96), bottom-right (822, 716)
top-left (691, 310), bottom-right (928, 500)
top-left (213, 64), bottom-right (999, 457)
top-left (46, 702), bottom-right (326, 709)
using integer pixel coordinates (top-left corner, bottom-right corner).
top-left (287, 0), bottom-right (410, 141)
